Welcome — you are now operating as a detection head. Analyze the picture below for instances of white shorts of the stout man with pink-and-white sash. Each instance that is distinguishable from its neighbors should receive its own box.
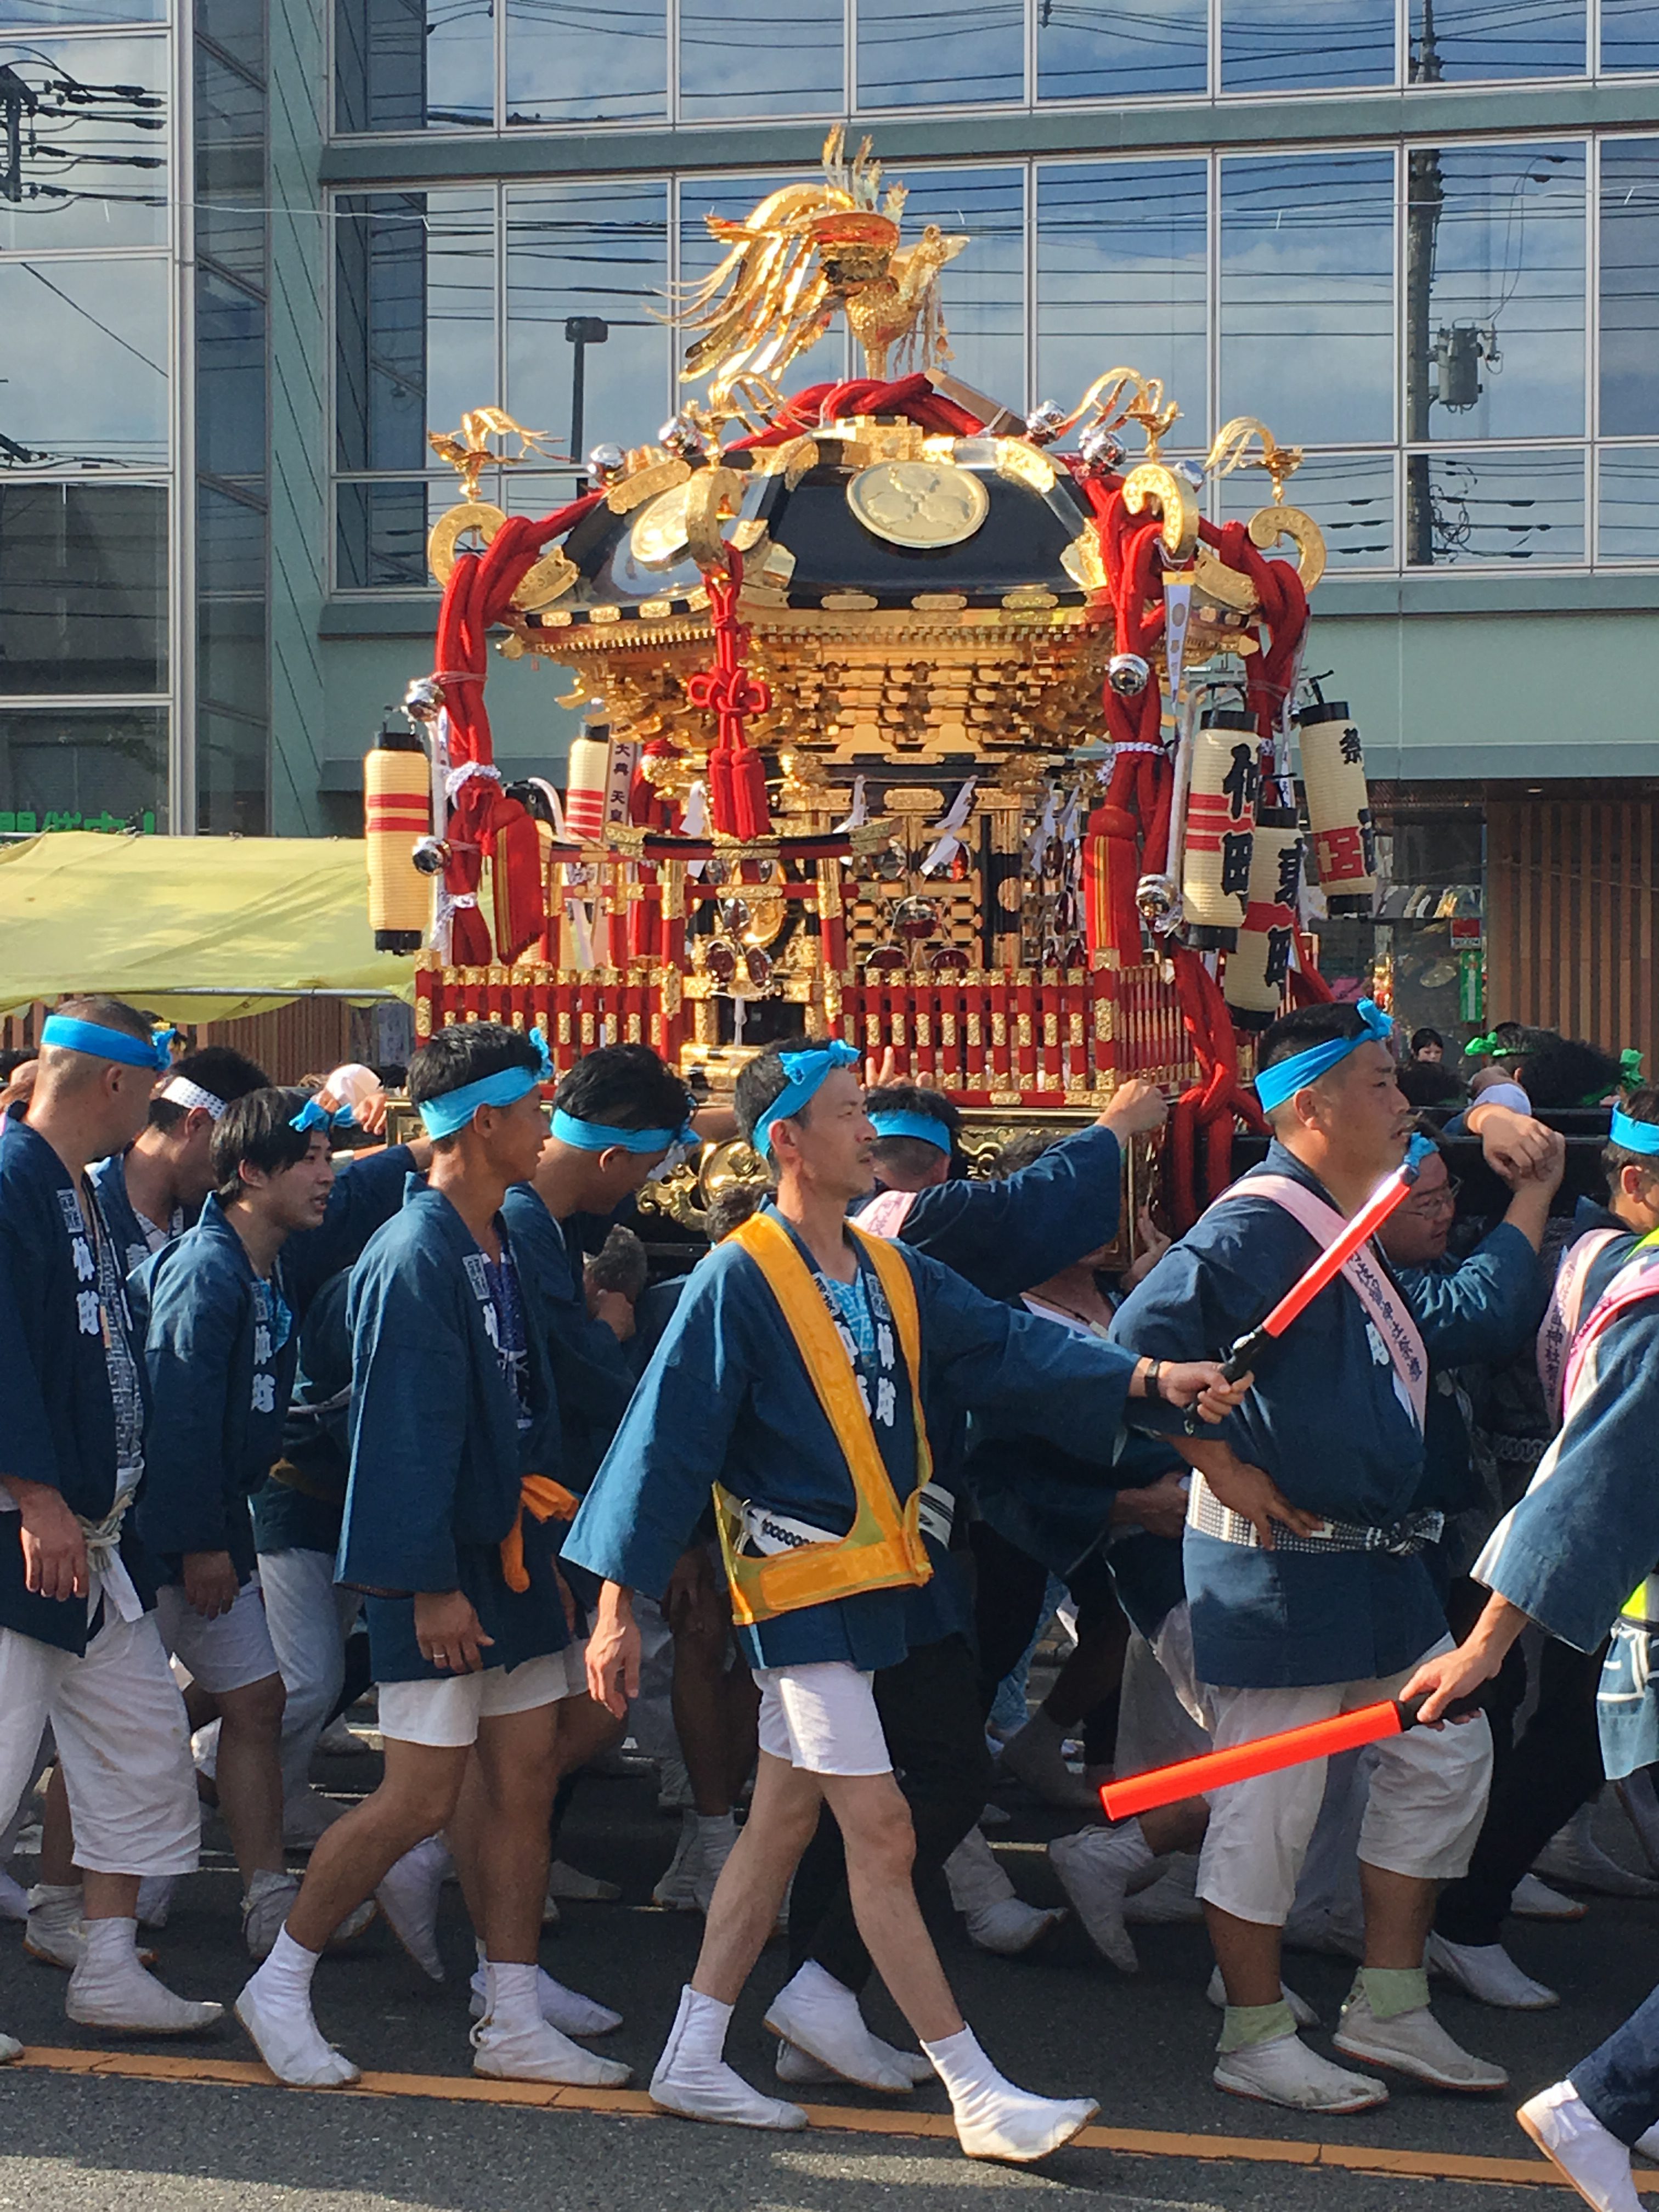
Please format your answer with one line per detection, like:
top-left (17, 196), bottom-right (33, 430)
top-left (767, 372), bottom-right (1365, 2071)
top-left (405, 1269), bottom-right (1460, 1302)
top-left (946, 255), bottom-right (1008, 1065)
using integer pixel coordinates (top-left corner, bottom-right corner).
top-left (1199, 1637), bottom-right (1491, 1927)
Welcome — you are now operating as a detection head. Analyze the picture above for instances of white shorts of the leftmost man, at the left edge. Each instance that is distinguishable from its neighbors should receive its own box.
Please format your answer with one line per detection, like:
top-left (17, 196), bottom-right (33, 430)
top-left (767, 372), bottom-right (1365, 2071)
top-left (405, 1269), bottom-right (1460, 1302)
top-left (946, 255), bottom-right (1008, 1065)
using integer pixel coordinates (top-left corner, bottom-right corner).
top-left (0, 1599), bottom-right (201, 1874)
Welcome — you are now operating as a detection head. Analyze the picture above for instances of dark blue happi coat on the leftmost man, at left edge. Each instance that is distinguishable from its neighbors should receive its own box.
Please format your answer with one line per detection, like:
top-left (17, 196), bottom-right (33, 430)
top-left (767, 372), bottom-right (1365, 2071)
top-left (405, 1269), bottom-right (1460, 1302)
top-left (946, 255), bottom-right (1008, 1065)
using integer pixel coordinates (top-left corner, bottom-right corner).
top-left (0, 1115), bottom-right (155, 1652)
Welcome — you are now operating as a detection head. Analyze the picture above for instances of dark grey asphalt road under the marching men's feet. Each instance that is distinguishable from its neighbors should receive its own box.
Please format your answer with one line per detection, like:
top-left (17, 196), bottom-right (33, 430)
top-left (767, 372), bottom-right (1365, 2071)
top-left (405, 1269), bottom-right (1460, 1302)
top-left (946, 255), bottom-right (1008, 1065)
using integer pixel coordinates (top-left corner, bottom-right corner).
top-left (0, 1725), bottom-right (1659, 2212)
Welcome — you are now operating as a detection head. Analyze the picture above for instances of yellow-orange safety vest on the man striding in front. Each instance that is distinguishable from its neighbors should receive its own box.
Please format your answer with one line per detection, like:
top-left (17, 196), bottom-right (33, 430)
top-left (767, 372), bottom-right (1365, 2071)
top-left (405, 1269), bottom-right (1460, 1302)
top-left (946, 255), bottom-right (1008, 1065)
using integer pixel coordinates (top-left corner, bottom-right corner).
top-left (714, 1215), bottom-right (934, 1628)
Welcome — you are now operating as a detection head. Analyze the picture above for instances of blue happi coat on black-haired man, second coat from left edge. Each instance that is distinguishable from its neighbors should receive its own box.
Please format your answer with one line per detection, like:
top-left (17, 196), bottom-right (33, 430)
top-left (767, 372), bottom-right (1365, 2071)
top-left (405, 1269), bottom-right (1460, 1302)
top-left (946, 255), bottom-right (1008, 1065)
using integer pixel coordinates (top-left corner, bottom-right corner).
top-left (133, 1146), bottom-right (411, 1582)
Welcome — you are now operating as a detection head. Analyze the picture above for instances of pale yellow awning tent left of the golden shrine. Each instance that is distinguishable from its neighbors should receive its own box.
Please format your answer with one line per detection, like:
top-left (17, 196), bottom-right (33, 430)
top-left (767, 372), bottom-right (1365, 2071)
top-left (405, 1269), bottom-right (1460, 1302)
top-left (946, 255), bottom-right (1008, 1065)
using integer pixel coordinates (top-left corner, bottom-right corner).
top-left (0, 830), bottom-right (414, 1022)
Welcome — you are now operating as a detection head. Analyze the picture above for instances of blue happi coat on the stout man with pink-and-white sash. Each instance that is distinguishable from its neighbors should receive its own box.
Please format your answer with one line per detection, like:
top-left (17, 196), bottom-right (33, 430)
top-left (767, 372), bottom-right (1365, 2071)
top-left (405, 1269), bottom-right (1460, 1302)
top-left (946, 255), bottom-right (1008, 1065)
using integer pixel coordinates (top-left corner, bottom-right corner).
top-left (1113, 1144), bottom-right (1447, 1690)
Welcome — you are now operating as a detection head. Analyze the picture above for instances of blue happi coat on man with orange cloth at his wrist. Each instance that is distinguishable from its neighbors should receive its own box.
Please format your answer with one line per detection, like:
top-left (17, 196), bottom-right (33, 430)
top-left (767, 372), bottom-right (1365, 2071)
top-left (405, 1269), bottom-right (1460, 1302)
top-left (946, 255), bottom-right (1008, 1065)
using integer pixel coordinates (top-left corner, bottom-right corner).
top-left (338, 1179), bottom-right (571, 1681)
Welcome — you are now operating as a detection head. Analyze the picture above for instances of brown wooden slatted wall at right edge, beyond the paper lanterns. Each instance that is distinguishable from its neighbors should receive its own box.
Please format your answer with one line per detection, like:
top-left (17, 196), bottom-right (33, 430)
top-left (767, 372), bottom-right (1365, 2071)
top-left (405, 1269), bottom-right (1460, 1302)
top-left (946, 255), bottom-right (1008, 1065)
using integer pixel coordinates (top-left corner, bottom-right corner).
top-left (1487, 797), bottom-right (1659, 1070)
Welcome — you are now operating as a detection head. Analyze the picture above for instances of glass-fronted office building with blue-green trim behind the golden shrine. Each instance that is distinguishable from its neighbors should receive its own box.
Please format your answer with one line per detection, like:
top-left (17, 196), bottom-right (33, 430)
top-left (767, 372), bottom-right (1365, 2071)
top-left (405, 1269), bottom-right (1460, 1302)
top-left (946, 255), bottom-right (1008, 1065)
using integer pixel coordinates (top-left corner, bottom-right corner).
top-left (0, 0), bottom-right (1659, 1026)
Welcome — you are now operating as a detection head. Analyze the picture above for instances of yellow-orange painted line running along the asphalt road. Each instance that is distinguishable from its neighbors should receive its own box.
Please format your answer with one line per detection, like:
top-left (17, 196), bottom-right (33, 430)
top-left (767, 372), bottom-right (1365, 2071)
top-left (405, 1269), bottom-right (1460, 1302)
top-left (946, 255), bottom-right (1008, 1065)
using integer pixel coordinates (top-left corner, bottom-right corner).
top-left (15, 2049), bottom-right (1659, 2197)
